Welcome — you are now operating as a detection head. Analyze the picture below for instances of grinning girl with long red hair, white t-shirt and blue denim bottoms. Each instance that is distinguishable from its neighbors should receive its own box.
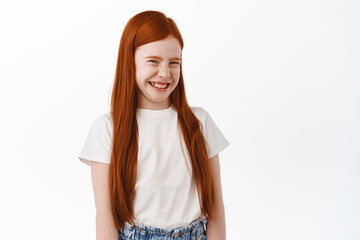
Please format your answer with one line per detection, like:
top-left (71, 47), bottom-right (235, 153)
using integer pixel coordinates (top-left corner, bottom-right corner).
top-left (79, 11), bottom-right (229, 240)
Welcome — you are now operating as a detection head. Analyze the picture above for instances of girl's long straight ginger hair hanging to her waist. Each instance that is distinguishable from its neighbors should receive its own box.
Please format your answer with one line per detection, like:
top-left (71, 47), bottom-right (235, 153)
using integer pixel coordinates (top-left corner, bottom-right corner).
top-left (109, 11), bottom-right (215, 229)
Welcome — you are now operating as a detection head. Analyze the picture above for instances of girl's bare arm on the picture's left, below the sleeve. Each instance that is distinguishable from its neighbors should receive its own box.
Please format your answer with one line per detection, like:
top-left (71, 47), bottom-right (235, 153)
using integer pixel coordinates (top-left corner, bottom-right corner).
top-left (91, 161), bottom-right (119, 240)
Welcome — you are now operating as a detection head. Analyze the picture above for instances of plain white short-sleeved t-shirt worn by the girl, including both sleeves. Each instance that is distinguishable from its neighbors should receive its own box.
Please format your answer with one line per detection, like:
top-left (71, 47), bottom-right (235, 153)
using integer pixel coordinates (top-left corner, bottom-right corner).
top-left (79, 107), bottom-right (229, 228)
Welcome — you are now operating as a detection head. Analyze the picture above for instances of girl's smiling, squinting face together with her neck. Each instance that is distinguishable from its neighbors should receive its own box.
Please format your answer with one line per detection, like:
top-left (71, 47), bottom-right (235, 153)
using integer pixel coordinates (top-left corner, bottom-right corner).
top-left (135, 35), bottom-right (181, 110)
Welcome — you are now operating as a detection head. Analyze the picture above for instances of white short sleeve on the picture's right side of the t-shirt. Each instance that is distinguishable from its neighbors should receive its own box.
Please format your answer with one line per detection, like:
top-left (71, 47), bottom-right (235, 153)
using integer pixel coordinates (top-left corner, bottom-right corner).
top-left (195, 108), bottom-right (230, 158)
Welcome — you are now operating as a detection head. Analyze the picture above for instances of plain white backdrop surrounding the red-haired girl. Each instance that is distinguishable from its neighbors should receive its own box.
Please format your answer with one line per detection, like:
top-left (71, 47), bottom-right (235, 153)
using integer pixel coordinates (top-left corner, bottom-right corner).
top-left (0, 0), bottom-right (360, 240)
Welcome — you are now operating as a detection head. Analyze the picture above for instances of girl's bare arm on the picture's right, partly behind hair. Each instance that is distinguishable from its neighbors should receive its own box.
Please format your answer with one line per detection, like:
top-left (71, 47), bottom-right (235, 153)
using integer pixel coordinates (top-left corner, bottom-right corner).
top-left (206, 154), bottom-right (226, 240)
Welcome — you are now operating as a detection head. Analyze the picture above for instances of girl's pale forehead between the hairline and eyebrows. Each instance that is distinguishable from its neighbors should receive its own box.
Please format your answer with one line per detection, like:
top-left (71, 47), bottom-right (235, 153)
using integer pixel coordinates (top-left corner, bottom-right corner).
top-left (135, 36), bottom-right (181, 58)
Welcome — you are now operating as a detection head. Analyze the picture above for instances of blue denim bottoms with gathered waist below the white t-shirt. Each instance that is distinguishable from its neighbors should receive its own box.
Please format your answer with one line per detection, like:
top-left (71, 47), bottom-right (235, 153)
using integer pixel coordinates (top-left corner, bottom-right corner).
top-left (118, 218), bottom-right (207, 240)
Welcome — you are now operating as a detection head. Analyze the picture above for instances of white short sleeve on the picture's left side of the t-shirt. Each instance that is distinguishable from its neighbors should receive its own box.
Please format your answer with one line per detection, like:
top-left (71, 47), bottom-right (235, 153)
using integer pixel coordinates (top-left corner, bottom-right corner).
top-left (78, 114), bottom-right (112, 166)
